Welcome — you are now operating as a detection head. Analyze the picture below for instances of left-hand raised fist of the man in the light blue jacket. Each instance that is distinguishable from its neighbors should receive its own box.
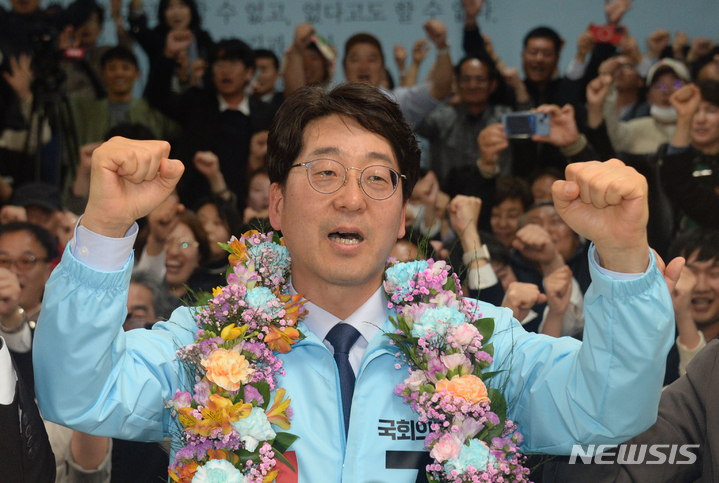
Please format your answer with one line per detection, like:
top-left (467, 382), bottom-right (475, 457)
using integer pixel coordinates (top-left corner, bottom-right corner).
top-left (81, 136), bottom-right (185, 242)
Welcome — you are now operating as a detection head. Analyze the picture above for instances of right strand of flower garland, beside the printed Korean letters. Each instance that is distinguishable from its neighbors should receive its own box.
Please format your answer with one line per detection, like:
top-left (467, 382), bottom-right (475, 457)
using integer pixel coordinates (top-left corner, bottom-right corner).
top-left (384, 260), bottom-right (529, 483)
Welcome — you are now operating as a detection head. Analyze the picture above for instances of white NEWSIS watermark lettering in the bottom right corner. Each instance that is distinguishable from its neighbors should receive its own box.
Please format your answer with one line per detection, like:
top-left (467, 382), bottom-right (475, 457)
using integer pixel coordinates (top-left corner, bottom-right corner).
top-left (569, 444), bottom-right (699, 465)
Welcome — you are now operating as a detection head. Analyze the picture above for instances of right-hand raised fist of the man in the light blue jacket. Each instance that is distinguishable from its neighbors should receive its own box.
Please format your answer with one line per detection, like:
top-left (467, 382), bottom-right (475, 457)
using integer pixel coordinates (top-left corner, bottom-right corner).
top-left (552, 159), bottom-right (684, 282)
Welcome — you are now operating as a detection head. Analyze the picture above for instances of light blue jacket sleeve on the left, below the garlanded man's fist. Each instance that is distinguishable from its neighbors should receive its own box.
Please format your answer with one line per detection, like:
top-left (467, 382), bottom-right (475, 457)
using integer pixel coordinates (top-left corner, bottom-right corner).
top-left (33, 249), bottom-right (195, 441)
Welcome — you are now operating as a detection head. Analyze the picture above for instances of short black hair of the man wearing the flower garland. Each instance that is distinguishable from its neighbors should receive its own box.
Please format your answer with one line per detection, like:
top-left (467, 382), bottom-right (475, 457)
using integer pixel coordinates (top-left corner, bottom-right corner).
top-left (267, 82), bottom-right (421, 201)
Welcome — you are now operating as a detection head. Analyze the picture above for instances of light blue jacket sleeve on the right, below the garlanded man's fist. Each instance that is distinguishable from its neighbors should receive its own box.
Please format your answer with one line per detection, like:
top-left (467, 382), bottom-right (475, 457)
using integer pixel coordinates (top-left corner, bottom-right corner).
top-left (485, 247), bottom-right (674, 454)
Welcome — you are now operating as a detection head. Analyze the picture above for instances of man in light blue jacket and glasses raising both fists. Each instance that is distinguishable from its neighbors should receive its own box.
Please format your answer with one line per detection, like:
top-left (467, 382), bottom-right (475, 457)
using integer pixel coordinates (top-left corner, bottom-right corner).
top-left (35, 84), bottom-right (682, 482)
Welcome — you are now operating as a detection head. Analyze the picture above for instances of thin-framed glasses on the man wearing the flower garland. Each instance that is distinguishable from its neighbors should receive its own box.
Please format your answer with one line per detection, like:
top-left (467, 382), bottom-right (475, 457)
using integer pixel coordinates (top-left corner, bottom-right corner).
top-left (290, 159), bottom-right (407, 200)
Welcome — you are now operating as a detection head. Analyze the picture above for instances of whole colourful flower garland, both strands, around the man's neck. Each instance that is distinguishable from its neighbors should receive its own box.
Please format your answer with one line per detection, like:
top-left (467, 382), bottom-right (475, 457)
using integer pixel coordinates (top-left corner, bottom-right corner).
top-left (166, 231), bottom-right (529, 483)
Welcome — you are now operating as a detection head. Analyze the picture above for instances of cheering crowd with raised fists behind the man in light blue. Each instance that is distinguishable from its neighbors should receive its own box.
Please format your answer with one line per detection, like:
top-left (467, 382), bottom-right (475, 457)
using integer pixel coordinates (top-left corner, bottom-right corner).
top-left (0, 0), bottom-right (719, 482)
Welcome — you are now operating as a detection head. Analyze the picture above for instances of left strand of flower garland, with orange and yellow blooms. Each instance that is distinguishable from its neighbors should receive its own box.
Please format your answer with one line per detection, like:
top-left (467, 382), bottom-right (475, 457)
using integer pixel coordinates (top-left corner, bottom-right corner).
top-left (167, 231), bottom-right (304, 483)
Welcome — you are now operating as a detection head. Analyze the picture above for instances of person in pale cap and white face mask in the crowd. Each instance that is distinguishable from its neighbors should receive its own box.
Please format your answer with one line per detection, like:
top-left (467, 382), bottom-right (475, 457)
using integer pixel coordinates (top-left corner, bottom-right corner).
top-left (587, 58), bottom-right (691, 154)
